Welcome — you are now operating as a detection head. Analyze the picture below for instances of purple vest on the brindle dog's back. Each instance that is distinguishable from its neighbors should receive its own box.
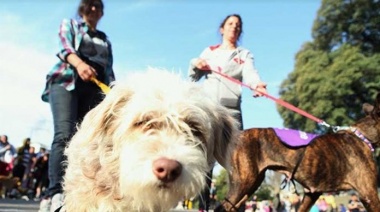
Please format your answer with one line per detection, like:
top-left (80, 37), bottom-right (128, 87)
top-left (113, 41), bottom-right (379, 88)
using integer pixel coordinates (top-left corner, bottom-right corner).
top-left (273, 128), bottom-right (319, 147)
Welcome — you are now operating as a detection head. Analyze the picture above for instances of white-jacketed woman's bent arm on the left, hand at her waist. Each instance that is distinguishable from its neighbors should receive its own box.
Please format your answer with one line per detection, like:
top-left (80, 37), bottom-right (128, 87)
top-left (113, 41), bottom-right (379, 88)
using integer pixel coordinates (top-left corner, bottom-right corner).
top-left (188, 48), bottom-right (210, 82)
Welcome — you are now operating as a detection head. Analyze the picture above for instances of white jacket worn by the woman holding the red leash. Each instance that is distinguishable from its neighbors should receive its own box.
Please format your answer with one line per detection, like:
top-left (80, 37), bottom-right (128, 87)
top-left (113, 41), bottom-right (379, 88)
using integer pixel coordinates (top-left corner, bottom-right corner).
top-left (188, 45), bottom-right (261, 111)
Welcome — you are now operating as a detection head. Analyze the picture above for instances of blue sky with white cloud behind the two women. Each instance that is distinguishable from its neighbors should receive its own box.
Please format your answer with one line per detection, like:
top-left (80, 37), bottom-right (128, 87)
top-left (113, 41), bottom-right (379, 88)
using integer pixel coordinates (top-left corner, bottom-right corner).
top-left (0, 0), bottom-right (321, 149)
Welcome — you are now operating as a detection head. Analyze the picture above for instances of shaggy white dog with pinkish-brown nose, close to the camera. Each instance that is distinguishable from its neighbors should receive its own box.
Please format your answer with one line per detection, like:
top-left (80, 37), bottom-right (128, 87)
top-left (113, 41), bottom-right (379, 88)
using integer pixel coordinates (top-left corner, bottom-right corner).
top-left (64, 70), bottom-right (238, 212)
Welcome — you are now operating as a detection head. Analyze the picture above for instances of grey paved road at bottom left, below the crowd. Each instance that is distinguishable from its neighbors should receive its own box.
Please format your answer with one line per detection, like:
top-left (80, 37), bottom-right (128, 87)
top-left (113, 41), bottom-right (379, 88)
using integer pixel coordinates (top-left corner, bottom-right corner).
top-left (0, 199), bottom-right (197, 212)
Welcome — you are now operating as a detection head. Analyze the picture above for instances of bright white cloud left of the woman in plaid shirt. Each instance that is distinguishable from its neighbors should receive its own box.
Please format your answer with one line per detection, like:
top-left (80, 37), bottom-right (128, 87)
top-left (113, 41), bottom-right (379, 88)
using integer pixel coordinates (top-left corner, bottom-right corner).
top-left (0, 13), bottom-right (55, 147)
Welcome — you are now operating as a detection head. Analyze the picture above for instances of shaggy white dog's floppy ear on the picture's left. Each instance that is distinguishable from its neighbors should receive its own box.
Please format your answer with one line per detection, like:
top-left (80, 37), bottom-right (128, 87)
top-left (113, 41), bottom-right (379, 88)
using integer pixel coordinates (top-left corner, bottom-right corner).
top-left (65, 85), bottom-right (132, 184)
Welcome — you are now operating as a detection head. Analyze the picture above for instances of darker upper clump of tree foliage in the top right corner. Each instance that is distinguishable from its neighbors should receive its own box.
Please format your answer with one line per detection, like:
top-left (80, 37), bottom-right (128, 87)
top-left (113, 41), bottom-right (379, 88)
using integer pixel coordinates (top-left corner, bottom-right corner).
top-left (312, 0), bottom-right (380, 53)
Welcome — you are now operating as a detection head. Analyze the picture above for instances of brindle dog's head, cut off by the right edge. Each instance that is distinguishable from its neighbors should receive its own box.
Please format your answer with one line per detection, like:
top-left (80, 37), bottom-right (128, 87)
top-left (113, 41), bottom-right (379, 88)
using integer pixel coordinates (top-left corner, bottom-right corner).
top-left (353, 93), bottom-right (380, 147)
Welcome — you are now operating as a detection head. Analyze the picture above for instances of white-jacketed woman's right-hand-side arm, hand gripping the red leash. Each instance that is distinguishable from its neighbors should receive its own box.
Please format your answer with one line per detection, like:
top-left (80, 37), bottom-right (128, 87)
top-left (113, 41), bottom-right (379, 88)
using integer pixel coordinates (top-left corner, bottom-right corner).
top-left (242, 52), bottom-right (267, 97)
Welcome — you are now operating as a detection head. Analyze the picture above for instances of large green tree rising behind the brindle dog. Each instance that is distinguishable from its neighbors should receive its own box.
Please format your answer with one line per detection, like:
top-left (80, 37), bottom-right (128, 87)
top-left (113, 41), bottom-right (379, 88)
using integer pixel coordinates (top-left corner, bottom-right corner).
top-left (277, 0), bottom-right (380, 133)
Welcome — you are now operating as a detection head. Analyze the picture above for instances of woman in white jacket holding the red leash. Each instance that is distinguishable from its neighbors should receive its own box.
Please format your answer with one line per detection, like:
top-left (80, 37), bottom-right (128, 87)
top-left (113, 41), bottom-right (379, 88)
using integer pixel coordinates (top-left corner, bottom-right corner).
top-left (189, 14), bottom-right (267, 211)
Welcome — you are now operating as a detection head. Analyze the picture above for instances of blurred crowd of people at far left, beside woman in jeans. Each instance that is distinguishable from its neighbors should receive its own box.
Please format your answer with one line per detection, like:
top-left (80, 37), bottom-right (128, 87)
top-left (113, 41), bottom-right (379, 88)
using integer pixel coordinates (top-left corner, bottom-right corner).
top-left (0, 135), bottom-right (49, 201)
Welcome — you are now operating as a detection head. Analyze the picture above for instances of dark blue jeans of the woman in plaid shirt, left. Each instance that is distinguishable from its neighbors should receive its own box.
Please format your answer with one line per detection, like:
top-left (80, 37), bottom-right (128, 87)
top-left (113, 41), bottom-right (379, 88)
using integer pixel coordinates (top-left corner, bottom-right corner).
top-left (47, 81), bottom-right (103, 197)
